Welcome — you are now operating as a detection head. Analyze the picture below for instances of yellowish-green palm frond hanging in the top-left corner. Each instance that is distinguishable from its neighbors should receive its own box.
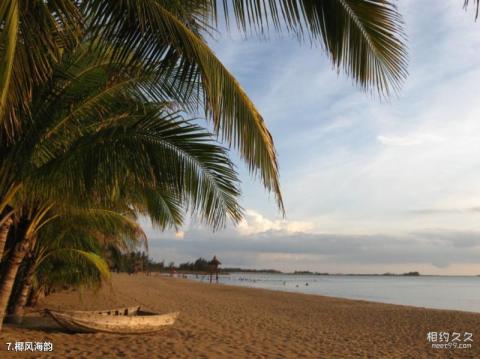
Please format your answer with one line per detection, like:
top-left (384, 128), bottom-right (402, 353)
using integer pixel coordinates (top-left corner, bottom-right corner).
top-left (0, 0), bottom-right (83, 140)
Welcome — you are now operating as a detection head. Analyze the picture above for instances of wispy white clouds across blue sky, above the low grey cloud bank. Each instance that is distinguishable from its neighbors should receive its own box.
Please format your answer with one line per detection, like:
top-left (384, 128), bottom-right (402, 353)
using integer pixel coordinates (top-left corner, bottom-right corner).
top-left (206, 0), bottom-right (480, 239)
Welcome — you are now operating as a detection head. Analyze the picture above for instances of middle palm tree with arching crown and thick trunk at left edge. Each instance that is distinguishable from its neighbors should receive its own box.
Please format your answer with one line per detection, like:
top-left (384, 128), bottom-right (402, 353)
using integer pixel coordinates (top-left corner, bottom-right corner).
top-left (0, 41), bottom-right (242, 330)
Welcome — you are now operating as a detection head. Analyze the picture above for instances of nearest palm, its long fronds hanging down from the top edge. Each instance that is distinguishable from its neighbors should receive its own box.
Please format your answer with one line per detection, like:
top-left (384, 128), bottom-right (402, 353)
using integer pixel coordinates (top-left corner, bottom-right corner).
top-left (0, 0), bottom-right (412, 260)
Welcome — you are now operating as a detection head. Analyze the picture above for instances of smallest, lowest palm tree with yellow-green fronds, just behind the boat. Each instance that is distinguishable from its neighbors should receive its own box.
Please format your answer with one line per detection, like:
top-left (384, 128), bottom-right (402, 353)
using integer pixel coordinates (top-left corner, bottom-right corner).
top-left (10, 208), bottom-right (146, 323)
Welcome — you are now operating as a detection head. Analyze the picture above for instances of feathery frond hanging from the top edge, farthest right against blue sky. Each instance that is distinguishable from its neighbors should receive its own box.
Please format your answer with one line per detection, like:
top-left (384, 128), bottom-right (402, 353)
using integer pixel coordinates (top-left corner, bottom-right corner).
top-left (216, 0), bottom-right (407, 96)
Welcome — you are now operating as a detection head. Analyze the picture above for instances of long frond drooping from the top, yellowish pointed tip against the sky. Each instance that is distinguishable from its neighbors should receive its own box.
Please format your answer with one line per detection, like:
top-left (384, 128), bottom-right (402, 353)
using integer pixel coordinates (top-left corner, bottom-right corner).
top-left (85, 0), bottom-right (283, 211)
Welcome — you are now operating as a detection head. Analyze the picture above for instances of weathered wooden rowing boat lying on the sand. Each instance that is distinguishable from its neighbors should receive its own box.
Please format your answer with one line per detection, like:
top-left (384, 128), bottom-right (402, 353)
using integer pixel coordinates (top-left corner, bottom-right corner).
top-left (45, 307), bottom-right (179, 334)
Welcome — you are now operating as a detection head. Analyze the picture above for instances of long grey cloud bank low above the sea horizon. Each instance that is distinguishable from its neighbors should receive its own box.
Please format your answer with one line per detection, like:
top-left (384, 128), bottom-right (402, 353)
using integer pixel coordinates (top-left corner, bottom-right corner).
top-left (150, 229), bottom-right (480, 274)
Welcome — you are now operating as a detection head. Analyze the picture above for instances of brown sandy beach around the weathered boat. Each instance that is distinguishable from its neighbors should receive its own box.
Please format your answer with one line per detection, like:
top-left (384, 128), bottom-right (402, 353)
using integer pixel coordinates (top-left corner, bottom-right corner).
top-left (0, 274), bottom-right (480, 359)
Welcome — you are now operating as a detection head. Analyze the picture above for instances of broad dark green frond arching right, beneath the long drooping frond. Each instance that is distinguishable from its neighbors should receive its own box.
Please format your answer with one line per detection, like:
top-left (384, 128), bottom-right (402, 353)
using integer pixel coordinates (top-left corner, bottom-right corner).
top-left (35, 106), bottom-right (242, 228)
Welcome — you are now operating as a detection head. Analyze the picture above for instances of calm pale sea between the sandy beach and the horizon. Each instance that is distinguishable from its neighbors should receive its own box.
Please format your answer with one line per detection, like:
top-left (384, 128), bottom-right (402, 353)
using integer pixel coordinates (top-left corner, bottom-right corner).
top-left (188, 273), bottom-right (480, 312)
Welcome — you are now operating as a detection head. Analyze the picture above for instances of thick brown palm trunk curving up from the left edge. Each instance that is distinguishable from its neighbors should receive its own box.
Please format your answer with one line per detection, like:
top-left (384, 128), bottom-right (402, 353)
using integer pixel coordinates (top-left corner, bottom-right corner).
top-left (0, 238), bottom-right (32, 331)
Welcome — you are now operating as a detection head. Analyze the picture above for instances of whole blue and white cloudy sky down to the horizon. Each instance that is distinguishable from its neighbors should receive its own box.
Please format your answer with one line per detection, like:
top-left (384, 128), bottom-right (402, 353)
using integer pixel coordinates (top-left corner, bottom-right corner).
top-left (143, 0), bottom-right (480, 275)
